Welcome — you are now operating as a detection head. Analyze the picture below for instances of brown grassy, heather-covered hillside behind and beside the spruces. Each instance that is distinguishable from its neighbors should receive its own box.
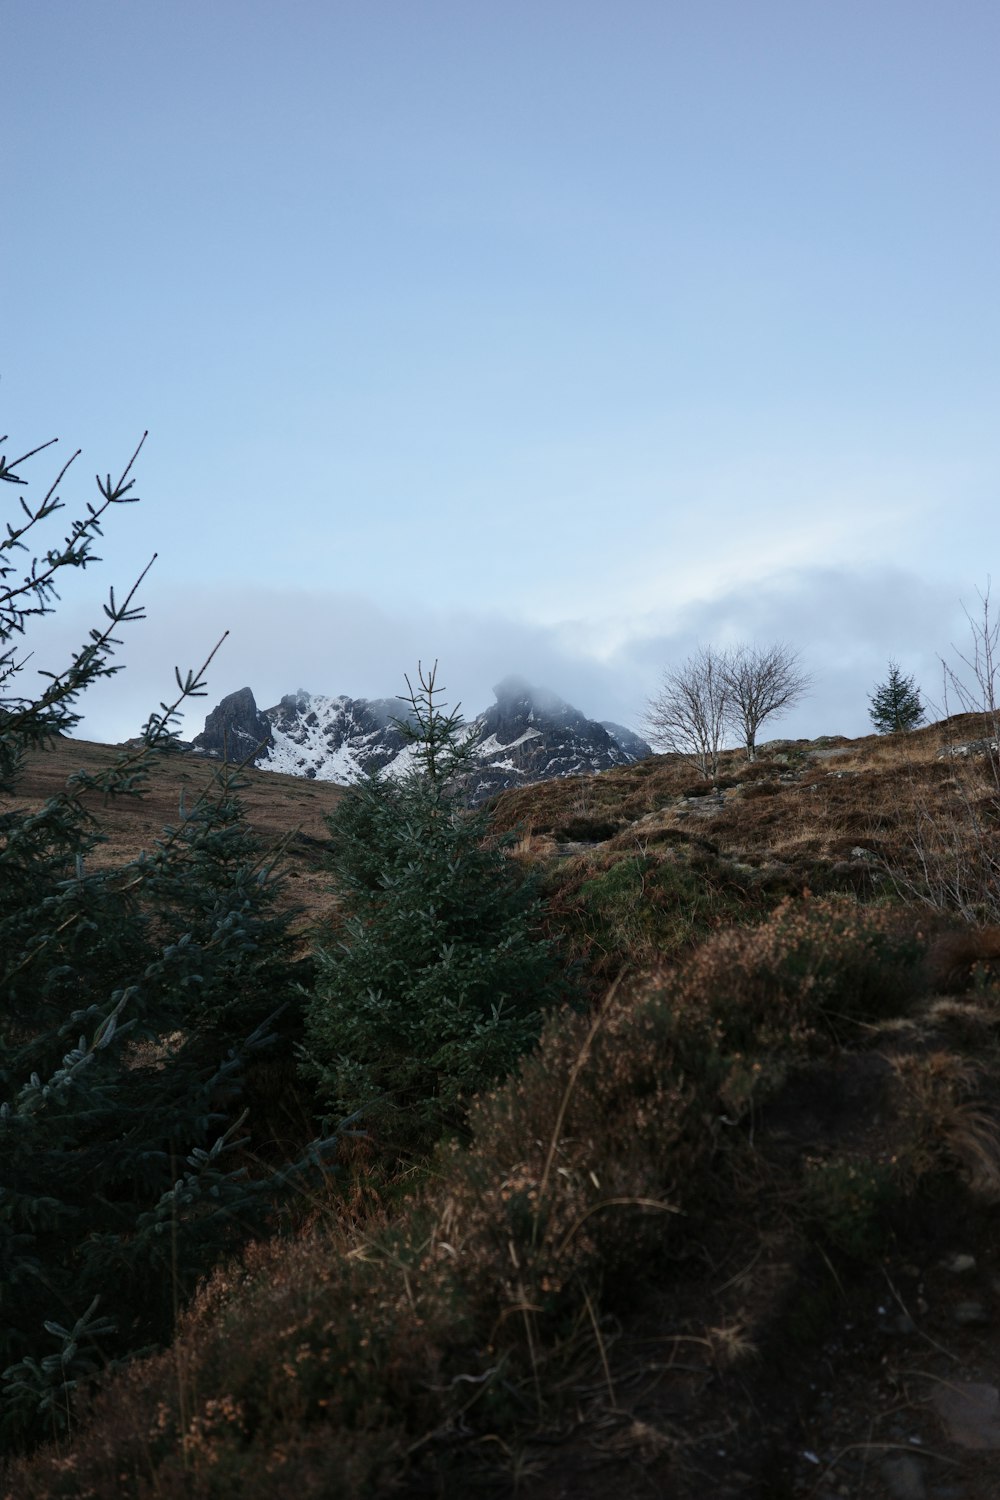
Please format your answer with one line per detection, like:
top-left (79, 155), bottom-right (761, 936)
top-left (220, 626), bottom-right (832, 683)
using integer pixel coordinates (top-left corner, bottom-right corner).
top-left (0, 716), bottom-right (1000, 1500)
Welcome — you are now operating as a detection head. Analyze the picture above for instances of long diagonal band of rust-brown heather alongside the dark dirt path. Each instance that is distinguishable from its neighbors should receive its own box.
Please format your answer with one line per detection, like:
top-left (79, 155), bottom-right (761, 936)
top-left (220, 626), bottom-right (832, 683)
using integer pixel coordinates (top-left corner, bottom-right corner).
top-left (0, 882), bottom-right (947, 1500)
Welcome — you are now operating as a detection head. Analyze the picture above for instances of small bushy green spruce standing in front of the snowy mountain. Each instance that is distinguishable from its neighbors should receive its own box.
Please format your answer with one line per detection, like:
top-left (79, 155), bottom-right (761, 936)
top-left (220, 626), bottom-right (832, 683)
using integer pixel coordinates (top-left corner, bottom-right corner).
top-left (296, 671), bottom-right (556, 1158)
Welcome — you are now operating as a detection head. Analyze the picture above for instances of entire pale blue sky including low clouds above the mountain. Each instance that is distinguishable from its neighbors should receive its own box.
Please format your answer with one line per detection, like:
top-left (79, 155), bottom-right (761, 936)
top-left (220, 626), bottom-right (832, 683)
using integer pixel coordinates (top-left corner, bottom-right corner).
top-left (0, 0), bottom-right (1000, 740)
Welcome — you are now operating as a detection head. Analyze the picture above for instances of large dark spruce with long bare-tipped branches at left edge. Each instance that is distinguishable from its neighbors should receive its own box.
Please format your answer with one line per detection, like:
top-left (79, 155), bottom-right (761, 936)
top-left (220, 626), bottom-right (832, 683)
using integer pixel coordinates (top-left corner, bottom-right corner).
top-left (0, 423), bottom-right (335, 1446)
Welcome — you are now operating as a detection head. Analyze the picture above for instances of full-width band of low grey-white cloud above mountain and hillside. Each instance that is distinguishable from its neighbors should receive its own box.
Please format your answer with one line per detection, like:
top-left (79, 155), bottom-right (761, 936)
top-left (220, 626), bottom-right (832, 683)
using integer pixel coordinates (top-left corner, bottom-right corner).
top-left (19, 567), bottom-right (970, 741)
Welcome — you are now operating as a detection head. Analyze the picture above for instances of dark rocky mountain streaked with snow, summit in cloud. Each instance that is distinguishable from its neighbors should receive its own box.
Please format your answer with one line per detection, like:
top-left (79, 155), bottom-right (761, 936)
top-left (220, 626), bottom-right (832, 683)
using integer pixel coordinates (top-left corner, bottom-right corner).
top-left (193, 677), bottom-right (652, 801)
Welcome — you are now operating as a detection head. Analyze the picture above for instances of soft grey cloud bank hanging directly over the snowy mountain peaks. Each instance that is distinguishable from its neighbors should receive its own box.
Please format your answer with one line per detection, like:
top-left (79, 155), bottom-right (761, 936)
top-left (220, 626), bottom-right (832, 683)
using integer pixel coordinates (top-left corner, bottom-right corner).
top-left (19, 587), bottom-right (644, 741)
